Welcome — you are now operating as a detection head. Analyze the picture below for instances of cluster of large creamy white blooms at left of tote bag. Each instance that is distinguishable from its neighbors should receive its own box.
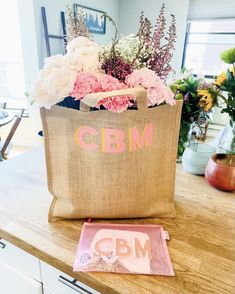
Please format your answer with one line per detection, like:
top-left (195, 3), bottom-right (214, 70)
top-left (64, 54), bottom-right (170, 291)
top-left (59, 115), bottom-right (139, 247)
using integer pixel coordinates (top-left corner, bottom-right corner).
top-left (33, 37), bottom-right (101, 108)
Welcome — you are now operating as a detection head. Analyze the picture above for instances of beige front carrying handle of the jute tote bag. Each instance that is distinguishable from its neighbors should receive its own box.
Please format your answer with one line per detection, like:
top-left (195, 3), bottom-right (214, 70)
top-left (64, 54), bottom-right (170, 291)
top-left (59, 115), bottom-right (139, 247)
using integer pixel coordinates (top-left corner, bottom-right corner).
top-left (80, 87), bottom-right (147, 111)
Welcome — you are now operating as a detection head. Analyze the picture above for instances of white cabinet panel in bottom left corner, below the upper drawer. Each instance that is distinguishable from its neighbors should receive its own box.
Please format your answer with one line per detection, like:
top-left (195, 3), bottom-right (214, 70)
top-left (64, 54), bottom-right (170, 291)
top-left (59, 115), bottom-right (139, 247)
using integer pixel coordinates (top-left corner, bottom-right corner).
top-left (0, 261), bottom-right (43, 294)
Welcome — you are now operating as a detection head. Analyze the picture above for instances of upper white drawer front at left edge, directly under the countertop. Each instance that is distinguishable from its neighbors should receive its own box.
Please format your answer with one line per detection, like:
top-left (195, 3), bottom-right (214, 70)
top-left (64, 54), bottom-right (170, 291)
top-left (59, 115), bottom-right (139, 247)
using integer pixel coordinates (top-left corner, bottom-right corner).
top-left (0, 239), bottom-right (41, 282)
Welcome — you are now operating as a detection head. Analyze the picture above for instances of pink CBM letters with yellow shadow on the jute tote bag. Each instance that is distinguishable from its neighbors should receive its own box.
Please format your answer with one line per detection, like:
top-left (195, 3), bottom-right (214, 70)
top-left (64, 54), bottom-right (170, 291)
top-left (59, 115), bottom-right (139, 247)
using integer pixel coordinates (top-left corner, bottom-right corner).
top-left (75, 123), bottom-right (153, 153)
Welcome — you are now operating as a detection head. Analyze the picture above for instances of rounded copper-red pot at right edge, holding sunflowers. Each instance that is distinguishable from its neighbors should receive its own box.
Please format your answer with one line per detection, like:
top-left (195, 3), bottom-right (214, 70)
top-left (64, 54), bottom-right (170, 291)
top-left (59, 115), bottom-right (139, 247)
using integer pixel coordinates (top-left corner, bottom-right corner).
top-left (205, 154), bottom-right (235, 191)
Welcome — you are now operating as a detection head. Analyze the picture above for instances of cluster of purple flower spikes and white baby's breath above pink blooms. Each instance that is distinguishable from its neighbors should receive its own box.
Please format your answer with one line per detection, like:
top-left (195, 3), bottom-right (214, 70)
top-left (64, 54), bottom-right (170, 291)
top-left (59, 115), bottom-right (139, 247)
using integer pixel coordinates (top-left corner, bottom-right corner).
top-left (100, 4), bottom-right (176, 80)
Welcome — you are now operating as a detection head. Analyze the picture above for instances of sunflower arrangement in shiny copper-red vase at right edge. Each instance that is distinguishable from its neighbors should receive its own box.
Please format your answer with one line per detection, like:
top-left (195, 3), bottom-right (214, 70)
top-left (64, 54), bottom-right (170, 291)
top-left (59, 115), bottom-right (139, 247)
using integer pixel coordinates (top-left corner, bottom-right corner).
top-left (198, 48), bottom-right (235, 191)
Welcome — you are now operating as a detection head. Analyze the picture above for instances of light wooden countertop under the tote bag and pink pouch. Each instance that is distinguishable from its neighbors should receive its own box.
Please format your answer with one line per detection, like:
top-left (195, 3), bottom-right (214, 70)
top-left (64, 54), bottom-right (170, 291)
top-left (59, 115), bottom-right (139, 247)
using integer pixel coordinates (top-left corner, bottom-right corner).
top-left (0, 150), bottom-right (235, 294)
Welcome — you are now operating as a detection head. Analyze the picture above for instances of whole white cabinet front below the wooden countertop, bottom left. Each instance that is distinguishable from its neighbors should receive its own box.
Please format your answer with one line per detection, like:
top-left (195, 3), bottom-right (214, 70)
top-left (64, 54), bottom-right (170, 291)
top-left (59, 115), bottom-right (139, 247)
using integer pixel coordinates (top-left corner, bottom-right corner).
top-left (0, 239), bottom-right (100, 294)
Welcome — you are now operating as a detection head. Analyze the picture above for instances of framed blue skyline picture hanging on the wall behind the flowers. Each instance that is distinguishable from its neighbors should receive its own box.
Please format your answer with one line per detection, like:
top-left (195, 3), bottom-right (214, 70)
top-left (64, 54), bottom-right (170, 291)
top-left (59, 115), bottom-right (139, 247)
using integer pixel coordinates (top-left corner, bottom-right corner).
top-left (73, 4), bottom-right (106, 34)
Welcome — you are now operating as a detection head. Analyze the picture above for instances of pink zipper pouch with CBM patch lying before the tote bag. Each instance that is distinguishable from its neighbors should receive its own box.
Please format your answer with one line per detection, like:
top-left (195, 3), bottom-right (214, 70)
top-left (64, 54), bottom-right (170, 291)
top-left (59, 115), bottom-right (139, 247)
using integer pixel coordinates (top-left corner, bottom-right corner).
top-left (73, 223), bottom-right (175, 276)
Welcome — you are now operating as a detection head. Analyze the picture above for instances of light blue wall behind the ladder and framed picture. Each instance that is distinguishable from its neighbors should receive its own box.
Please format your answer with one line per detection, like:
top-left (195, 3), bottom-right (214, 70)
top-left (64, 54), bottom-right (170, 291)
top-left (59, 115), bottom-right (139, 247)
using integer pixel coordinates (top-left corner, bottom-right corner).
top-left (33, 0), bottom-right (119, 67)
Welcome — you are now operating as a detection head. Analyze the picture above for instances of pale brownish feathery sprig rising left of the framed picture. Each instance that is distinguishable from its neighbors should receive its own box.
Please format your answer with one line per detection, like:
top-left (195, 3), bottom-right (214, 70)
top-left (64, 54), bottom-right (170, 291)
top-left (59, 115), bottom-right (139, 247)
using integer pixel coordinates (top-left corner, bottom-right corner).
top-left (65, 6), bottom-right (93, 42)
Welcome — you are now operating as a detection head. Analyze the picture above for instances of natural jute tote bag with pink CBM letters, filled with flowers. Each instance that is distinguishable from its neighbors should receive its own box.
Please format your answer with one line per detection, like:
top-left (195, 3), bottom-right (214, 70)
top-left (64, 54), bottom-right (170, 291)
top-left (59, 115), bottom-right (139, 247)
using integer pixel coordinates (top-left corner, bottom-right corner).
top-left (41, 88), bottom-right (182, 221)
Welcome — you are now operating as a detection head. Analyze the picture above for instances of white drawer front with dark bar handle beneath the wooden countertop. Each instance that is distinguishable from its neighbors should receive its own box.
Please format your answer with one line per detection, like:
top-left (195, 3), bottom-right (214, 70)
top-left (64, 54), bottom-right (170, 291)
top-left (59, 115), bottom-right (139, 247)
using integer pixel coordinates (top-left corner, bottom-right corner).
top-left (41, 262), bottom-right (100, 294)
